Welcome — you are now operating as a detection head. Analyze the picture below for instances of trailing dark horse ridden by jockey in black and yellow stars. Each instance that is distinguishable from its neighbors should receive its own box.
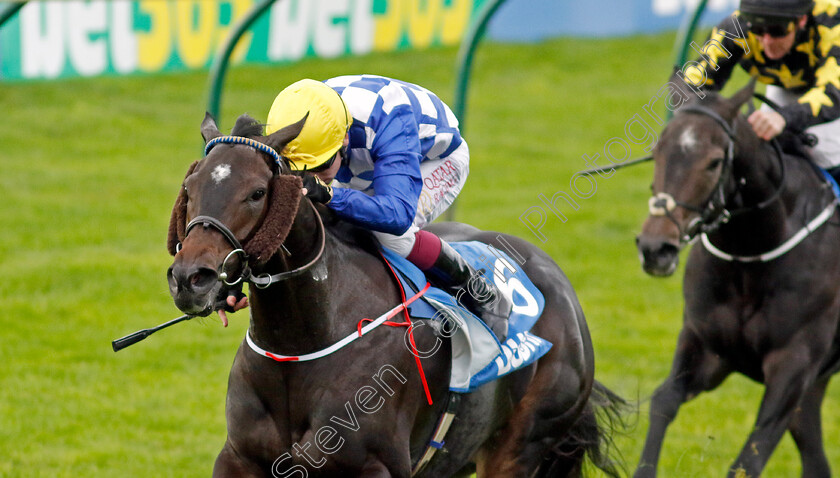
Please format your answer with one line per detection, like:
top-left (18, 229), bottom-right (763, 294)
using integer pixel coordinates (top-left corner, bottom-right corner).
top-left (635, 84), bottom-right (840, 478)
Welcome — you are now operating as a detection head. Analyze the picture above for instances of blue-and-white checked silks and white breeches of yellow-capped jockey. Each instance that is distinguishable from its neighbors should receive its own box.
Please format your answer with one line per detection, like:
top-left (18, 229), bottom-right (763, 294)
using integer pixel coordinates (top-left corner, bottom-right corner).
top-left (326, 75), bottom-right (469, 239)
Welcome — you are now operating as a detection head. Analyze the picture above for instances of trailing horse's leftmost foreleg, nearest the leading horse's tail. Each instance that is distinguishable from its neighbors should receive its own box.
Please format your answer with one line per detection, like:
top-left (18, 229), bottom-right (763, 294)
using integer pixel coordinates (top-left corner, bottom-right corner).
top-left (633, 328), bottom-right (731, 478)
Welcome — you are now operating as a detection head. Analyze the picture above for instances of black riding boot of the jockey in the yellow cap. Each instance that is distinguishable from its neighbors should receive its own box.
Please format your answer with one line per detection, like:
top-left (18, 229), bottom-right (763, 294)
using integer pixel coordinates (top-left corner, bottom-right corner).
top-left (426, 239), bottom-right (512, 342)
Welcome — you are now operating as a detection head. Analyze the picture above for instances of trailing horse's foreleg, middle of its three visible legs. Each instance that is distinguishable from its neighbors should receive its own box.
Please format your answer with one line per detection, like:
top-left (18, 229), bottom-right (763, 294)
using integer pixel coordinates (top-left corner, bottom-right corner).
top-left (728, 343), bottom-right (816, 478)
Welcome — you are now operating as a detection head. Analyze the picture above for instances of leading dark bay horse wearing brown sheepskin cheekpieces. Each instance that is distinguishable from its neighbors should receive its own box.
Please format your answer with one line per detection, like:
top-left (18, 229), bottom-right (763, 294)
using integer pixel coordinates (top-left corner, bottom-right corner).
top-left (168, 115), bottom-right (620, 478)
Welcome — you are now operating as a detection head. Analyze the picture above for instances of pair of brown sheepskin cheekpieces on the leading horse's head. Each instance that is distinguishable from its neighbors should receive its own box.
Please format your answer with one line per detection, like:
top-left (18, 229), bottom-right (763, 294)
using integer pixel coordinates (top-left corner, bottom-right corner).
top-left (166, 161), bottom-right (303, 267)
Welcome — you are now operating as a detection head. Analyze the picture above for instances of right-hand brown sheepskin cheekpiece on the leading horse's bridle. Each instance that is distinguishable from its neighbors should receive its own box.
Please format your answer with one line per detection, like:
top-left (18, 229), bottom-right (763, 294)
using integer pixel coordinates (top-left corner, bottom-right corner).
top-left (244, 174), bottom-right (303, 267)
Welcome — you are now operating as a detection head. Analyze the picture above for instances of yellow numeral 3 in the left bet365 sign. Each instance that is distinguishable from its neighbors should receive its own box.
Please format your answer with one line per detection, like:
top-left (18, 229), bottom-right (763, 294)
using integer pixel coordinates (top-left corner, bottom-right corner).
top-left (136, 0), bottom-right (172, 71)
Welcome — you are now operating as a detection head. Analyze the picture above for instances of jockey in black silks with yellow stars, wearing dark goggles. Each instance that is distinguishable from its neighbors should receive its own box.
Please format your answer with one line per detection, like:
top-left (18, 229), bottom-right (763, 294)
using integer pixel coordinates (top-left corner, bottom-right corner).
top-left (684, 0), bottom-right (840, 169)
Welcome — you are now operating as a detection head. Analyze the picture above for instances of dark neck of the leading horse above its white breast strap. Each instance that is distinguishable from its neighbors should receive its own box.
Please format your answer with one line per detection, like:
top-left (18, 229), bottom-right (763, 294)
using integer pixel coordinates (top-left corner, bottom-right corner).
top-left (244, 201), bottom-right (386, 355)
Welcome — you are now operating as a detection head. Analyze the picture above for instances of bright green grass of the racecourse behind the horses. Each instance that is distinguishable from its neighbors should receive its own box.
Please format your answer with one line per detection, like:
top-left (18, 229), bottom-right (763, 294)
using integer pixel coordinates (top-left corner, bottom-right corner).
top-left (0, 31), bottom-right (840, 477)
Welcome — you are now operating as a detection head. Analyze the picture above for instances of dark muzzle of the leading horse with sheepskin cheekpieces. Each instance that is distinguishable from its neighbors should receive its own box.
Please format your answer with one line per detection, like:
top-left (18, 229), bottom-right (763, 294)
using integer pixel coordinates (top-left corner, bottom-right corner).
top-left (166, 261), bottom-right (222, 317)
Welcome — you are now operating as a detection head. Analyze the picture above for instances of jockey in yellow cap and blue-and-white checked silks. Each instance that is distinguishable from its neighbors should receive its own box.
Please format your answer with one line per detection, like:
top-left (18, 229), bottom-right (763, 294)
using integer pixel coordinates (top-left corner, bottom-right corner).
top-left (266, 75), bottom-right (511, 335)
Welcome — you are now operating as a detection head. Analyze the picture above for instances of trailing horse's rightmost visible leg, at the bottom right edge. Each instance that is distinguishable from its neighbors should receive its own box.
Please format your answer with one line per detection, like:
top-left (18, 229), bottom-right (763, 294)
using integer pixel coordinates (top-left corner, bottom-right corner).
top-left (789, 379), bottom-right (831, 478)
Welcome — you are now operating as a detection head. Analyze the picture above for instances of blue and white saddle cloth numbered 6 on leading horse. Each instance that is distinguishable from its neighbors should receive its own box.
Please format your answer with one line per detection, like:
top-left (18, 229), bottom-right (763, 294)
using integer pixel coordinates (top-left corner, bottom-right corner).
top-left (382, 241), bottom-right (552, 393)
